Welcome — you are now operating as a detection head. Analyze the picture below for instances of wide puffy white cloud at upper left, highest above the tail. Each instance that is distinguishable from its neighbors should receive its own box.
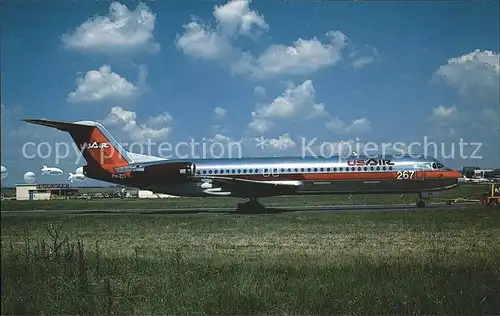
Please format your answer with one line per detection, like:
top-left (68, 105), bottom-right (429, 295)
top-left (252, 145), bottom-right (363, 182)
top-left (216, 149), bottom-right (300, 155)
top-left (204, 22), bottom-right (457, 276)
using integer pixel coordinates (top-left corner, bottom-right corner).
top-left (62, 2), bottom-right (160, 53)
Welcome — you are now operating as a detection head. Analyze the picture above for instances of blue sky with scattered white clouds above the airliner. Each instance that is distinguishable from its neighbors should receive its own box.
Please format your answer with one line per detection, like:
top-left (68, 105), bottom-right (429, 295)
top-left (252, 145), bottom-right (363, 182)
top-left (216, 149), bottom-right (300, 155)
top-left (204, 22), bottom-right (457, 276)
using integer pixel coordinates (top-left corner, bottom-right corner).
top-left (1, 1), bottom-right (500, 185)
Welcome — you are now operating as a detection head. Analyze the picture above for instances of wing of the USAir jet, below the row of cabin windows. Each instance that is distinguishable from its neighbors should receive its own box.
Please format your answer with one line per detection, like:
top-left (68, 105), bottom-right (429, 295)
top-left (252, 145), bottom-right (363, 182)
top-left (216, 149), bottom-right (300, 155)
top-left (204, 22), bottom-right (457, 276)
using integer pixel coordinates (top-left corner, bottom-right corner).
top-left (201, 176), bottom-right (302, 196)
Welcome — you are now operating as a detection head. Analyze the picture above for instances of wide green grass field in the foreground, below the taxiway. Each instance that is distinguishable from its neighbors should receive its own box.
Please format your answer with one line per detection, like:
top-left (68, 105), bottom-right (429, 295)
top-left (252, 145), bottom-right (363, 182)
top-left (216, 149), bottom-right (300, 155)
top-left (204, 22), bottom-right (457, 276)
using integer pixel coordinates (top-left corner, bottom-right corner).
top-left (1, 207), bottom-right (500, 315)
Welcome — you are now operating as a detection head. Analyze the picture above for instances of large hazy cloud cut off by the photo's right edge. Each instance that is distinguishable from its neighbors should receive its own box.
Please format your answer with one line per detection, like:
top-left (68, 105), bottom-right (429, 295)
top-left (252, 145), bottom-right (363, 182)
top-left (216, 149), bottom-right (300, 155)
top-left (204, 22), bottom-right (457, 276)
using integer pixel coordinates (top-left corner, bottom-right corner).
top-left (434, 49), bottom-right (500, 98)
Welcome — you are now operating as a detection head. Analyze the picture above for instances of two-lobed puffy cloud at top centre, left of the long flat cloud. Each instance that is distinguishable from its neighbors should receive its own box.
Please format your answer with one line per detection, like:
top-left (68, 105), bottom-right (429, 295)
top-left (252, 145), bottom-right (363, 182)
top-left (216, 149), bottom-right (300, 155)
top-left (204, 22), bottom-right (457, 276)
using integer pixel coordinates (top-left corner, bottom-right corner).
top-left (176, 0), bottom-right (269, 60)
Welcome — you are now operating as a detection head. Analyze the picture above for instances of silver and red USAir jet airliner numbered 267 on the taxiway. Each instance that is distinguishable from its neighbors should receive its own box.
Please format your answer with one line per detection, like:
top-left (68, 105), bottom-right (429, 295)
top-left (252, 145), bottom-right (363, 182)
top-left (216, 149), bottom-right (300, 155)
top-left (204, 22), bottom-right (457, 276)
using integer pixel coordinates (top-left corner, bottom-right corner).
top-left (23, 119), bottom-right (465, 210)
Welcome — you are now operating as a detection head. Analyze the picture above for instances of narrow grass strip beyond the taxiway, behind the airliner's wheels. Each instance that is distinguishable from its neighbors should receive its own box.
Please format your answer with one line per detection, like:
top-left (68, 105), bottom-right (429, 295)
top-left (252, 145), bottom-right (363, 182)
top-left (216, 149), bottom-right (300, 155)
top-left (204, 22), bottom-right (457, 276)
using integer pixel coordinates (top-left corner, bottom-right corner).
top-left (1, 185), bottom-right (487, 211)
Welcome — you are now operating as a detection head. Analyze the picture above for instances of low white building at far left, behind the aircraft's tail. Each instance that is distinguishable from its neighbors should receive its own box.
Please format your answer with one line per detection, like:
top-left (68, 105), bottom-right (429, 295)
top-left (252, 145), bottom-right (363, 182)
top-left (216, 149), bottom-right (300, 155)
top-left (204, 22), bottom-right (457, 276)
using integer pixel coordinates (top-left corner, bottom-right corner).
top-left (16, 183), bottom-right (79, 201)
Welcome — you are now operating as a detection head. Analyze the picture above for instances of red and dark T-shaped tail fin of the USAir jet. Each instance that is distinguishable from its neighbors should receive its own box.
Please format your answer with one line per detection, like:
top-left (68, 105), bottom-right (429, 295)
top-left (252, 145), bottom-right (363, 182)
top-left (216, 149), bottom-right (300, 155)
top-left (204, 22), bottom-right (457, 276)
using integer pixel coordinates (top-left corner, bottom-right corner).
top-left (23, 119), bottom-right (133, 172)
